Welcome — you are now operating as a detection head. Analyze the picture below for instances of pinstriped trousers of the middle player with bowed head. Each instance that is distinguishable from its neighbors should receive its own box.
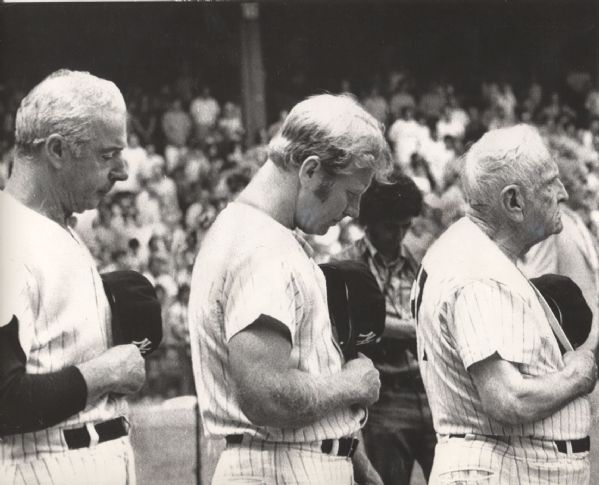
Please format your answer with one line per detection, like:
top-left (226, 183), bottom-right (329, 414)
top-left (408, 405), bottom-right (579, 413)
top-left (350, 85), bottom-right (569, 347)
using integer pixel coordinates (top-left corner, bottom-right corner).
top-left (212, 438), bottom-right (353, 485)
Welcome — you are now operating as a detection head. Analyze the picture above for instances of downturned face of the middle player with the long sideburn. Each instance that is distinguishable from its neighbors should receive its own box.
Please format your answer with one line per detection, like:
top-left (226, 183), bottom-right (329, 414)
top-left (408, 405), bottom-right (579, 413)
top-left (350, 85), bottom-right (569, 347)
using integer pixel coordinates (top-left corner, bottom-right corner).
top-left (295, 168), bottom-right (373, 234)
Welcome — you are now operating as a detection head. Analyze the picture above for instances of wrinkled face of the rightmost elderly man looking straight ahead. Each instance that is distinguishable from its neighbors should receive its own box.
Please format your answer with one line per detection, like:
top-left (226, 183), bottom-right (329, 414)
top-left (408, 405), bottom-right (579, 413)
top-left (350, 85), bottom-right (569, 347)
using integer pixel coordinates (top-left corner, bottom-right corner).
top-left (525, 159), bottom-right (568, 242)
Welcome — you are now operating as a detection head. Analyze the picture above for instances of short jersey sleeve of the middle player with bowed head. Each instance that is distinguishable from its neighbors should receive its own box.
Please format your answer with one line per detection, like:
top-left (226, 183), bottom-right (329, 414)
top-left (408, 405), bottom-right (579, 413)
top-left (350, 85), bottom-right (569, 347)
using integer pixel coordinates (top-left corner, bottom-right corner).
top-left (224, 248), bottom-right (302, 342)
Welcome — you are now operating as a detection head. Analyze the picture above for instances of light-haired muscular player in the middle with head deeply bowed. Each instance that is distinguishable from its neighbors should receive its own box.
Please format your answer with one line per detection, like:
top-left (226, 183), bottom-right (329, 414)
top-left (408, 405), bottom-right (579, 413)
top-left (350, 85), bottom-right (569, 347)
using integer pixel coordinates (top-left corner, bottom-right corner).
top-left (189, 94), bottom-right (390, 485)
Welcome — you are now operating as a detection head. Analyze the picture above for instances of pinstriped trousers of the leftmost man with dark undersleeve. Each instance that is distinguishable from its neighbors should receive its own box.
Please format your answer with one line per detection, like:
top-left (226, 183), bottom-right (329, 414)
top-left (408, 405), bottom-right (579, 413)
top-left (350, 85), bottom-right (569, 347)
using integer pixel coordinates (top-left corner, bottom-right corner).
top-left (0, 436), bottom-right (135, 485)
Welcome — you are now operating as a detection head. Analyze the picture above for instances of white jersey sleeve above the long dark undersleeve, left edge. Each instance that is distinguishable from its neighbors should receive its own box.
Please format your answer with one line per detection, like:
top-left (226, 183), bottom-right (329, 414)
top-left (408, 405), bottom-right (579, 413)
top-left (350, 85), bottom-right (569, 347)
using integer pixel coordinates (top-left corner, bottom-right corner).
top-left (0, 258), bottom-right (39, 358)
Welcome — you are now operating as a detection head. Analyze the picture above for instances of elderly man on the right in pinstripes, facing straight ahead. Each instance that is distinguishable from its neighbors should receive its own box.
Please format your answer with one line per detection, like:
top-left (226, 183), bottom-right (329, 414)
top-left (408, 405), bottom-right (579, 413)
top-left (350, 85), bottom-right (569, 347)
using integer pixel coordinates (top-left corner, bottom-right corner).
top-left (412, 125), bottom-right (597, 485)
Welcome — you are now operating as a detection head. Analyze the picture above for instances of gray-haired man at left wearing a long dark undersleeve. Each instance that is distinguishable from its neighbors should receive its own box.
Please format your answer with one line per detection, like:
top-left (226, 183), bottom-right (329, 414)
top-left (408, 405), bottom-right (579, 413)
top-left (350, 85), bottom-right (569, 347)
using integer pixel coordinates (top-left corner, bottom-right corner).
top-left (0, 70), bottom-right (145, 485)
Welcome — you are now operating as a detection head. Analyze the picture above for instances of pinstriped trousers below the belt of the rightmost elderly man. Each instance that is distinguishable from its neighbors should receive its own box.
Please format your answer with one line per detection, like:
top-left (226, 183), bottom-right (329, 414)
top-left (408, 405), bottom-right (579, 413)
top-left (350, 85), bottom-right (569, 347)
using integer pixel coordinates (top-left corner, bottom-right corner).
top-left (429, 435), bottom-right (590, 485)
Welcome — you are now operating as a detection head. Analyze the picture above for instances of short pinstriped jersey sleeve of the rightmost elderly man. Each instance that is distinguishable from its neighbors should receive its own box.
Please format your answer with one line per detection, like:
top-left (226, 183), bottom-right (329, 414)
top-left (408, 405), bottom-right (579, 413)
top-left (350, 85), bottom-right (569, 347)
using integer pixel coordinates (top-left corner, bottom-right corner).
top-left (450, 281), bottom-right (538, 368)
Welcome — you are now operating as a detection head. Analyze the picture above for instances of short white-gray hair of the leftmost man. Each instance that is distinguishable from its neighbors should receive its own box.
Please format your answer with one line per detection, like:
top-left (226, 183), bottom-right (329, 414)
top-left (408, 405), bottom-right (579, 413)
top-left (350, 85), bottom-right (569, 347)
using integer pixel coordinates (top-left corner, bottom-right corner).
top-left (15, 69), bottom-right (126, 155)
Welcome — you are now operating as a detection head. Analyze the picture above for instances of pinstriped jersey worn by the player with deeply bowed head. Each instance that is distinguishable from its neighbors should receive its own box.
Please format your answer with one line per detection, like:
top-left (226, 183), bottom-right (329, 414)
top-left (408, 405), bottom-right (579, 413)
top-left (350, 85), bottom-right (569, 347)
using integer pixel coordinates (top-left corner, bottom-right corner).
top-left (189, 203), bottom-right (366, 442)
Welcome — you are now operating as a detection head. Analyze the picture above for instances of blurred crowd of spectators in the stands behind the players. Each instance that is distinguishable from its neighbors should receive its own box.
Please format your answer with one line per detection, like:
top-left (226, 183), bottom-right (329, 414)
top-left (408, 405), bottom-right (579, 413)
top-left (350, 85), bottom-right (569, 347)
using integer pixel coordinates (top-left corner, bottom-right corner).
top-left (0, 72), bottom-right (599, 398)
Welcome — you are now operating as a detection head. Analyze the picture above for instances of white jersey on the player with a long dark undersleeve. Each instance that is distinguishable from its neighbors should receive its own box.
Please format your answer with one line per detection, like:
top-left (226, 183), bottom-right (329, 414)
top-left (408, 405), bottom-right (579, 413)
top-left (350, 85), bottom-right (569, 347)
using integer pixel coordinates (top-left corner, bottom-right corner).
top-left (0, 192), bottom-right (127, 464)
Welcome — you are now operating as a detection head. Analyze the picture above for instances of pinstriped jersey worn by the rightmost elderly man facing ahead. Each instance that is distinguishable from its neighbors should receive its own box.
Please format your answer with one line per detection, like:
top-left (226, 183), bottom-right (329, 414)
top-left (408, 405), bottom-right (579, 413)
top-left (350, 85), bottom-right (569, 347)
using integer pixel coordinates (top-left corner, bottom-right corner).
top-left (412, 218), bottom-right (590, 440)
